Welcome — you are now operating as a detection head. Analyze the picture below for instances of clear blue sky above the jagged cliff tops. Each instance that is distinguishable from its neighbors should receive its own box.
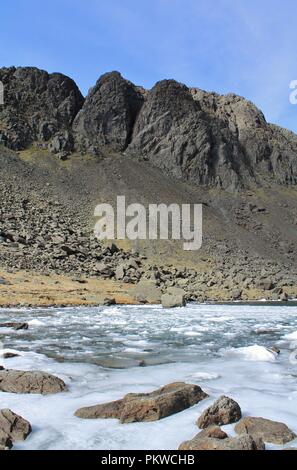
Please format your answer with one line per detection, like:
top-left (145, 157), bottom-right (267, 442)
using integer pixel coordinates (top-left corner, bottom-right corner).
top-left (0, 0), bottom-right (297, 132)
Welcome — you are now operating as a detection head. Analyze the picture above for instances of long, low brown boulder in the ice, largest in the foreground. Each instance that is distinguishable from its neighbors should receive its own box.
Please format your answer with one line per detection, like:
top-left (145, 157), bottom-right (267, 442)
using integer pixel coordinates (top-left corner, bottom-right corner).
top-left (75, 382), bottom-right (208, 423)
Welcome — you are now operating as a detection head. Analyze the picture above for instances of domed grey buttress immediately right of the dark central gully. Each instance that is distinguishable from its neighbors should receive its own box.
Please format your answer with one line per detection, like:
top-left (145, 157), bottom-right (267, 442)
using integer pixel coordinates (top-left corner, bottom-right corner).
top-left (128, 80), bottom-right (231, 184)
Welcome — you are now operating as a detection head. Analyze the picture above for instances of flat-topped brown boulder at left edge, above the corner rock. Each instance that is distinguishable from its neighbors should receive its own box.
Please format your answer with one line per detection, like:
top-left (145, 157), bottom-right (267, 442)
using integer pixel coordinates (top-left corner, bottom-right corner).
top-left (0, 369), bottom-right (66, 395)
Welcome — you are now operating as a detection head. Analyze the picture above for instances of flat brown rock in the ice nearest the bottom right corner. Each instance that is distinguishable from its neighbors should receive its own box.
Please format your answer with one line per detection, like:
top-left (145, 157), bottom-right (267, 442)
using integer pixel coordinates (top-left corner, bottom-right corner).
top-left (235, 417), bottom-right (297, 444)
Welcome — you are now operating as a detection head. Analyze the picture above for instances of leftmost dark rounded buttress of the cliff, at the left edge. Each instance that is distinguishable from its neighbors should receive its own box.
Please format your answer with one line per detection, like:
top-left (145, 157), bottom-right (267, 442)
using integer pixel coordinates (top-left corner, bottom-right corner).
top-left (0, 67), bottom-right (83, 151)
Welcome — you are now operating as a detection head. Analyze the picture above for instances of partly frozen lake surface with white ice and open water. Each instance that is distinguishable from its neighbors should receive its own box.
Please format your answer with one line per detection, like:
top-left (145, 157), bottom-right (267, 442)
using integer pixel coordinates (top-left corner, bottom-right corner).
top-left (0, 303), bottom-right (297, 450)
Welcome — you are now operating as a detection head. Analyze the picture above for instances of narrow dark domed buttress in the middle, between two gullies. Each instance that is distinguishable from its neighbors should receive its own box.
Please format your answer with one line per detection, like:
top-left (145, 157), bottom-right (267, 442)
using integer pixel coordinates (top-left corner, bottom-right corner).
top-left (73, 72), bottom-right (143, 153)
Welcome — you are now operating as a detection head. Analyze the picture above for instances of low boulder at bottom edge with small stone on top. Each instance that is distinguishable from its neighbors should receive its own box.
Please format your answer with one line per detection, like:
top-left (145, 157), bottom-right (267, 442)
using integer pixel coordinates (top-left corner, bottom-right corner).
top-left (179, 426), bottom-right (265, 450)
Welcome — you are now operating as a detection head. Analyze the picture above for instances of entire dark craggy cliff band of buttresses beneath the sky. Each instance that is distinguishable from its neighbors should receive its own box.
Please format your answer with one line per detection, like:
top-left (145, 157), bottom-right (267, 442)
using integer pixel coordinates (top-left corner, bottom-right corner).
top-left (0, 68), bottom-right (297, 191)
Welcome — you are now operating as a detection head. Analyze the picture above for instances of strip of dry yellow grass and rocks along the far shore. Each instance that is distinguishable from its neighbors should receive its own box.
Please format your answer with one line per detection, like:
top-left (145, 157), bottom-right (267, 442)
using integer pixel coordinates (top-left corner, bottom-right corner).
top-left (0, 271), bottom-right (296, 308)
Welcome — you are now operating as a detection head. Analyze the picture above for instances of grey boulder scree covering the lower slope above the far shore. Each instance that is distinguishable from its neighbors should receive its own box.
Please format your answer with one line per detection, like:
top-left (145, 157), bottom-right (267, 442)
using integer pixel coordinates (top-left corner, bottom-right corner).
top-left (0, 176), bottom-right (297, 306)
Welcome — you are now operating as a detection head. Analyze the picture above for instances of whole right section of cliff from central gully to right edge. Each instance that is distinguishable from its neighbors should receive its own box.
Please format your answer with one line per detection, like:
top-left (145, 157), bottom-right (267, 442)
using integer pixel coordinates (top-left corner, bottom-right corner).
top-left (129, 80), bottom-right (297, 190)
